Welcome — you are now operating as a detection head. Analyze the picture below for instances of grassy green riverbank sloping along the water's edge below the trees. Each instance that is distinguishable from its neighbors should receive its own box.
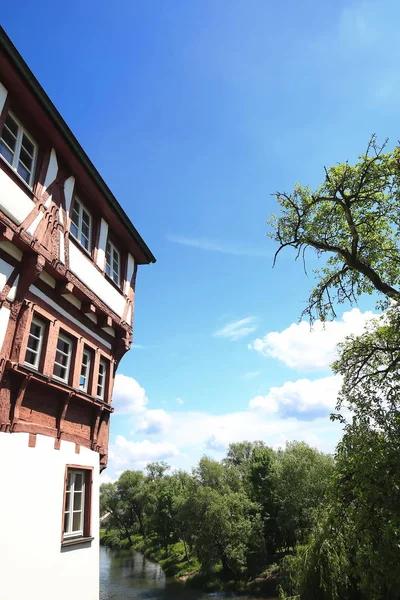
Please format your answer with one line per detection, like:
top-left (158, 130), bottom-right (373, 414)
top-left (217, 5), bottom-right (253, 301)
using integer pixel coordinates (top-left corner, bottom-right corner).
top-left (100, 530), bottom-right (280, 598)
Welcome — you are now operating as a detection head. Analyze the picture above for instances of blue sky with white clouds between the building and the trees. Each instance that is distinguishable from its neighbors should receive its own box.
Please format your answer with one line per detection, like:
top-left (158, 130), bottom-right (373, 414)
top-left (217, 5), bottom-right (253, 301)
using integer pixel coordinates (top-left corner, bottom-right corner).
top-left (2, 0), bottom-right (400, 476)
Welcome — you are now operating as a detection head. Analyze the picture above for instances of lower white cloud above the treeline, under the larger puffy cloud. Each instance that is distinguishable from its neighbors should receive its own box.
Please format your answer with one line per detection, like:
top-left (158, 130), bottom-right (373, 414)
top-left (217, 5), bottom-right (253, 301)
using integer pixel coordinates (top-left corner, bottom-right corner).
top-left (249, 375), bottom-right (342, 416)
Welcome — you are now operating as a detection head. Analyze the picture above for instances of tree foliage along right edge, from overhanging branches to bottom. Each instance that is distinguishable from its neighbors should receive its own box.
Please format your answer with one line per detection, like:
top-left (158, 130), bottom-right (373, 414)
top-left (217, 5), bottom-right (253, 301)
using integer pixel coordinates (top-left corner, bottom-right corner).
top-left (270, 136), bottom-right (400, 600)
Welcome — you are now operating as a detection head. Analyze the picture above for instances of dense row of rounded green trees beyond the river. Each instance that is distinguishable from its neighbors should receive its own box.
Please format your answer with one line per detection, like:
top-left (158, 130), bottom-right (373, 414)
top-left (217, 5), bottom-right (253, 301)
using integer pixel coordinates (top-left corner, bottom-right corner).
top-left (101, 442), bottom-right (334, 580)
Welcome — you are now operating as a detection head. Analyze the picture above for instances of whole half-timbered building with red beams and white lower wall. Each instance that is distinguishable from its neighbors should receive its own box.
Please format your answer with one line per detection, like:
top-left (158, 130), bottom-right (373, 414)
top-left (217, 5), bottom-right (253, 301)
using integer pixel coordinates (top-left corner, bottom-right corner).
top-left (0, 25), bottom-right (155, 600)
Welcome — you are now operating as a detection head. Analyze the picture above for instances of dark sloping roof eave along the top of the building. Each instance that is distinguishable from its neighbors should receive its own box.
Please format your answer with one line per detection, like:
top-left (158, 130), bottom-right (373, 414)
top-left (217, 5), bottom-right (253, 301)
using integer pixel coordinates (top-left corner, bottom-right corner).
top-left (0, 26), bottom-right (156, 263)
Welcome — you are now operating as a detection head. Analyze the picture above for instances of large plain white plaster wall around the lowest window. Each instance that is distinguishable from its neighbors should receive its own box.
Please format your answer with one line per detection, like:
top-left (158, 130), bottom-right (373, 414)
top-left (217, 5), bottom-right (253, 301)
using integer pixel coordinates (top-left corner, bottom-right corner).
top-left (0, 433), bottom-right (99, 600)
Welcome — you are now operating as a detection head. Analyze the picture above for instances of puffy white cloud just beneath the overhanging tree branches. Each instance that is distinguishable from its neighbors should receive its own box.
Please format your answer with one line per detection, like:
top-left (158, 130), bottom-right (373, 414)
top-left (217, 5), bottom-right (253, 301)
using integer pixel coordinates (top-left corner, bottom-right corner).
top-left (248, 308), bottom-right (378, 370)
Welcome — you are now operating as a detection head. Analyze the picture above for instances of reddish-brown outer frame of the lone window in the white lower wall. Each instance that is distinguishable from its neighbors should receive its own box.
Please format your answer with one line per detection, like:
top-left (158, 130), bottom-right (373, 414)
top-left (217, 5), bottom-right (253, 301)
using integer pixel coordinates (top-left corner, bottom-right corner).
top-left (61, 465), bottom-right (93, 546)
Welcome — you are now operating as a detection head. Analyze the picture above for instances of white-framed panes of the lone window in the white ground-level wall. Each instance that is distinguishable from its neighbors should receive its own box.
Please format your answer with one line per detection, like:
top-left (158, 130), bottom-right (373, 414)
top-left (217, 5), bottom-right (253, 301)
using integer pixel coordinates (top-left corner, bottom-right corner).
top-left (64, 469), bottom-right (85, 538)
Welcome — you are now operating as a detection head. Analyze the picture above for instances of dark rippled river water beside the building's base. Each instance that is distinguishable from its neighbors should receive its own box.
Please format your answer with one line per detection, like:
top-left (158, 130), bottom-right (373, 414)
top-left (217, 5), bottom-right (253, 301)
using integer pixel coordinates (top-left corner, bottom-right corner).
top-left (100, 546), bottom-right (272, 600)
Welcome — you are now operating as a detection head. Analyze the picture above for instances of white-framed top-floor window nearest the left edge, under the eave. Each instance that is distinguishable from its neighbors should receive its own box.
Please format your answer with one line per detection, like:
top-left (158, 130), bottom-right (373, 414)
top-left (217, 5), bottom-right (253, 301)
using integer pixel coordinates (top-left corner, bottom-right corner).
top-left (0, 113), bottom-right (37, 186)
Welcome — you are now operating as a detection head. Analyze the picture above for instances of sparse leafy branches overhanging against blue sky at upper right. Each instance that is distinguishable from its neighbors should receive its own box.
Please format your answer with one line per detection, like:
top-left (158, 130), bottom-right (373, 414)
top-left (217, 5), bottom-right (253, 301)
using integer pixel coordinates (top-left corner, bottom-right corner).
top-left (269, 136), bottom-right (400, 320)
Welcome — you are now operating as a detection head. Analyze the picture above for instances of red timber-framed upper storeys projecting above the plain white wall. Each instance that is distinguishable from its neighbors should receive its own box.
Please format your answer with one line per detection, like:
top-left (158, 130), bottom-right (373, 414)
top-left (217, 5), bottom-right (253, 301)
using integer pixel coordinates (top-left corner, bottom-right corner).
top-left (0, 28), bottom-right (155, 469)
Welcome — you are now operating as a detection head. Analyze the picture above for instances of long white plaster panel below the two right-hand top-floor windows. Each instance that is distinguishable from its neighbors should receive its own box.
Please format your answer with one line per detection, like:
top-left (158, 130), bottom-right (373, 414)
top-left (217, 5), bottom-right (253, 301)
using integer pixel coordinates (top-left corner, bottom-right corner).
top-left (69, 242), bottom-right (125, 318)
